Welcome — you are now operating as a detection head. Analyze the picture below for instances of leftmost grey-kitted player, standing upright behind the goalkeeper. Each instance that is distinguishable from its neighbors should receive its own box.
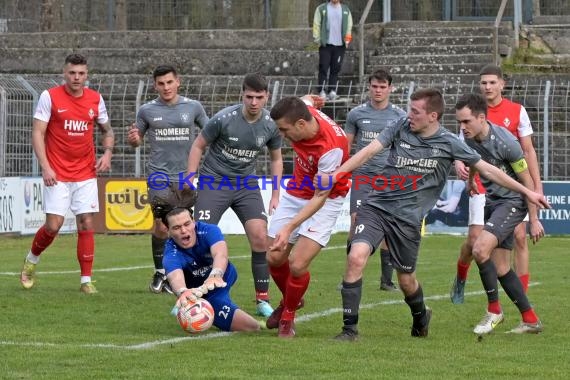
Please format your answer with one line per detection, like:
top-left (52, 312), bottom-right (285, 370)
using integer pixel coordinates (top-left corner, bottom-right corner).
top-left (127, 65), bottom-right (208, 293)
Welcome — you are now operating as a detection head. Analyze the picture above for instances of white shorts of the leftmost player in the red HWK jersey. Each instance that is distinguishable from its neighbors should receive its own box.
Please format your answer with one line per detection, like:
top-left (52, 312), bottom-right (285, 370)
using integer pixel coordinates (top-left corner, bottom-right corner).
top-left (43, 178), bottom-right (99, 216)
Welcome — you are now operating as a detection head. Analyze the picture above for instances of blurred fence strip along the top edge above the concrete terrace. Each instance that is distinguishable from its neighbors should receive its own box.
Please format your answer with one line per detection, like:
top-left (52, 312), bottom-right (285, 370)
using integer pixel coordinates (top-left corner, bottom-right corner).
top-left (0, 0), bottom-right (570, 33)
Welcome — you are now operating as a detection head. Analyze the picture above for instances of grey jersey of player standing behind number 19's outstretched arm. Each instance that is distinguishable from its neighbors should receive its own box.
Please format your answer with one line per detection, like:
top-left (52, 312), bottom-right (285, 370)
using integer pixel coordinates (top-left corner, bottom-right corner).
top-left (344, 102), bottom-right (406, 175)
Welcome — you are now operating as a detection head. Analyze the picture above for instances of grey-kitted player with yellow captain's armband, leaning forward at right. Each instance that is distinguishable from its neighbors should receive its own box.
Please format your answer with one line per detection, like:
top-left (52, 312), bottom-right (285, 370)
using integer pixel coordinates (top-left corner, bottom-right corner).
top-left (455, 94), bottom-right (544, 335)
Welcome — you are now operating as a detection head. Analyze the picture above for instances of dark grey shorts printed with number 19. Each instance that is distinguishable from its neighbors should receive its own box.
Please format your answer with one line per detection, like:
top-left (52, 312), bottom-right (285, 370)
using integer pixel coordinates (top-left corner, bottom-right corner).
top-left (350, 204), bottom-right (421, 273)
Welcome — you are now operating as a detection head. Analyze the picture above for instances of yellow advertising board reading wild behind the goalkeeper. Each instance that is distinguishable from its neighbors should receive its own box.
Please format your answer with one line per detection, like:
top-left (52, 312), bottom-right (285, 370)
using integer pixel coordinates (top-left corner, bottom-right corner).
top-left (104, 180), bottom-right (154, 232)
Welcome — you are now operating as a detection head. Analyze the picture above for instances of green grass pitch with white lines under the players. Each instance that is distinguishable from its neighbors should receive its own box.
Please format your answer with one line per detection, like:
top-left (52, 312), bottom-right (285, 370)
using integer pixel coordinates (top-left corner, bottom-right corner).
top-left (0, 234), bottom-right (570, 380)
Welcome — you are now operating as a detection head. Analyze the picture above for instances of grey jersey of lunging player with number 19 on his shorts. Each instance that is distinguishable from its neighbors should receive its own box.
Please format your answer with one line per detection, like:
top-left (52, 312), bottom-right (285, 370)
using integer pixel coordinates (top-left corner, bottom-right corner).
top-left (365, 119), bottom-right (481, 225)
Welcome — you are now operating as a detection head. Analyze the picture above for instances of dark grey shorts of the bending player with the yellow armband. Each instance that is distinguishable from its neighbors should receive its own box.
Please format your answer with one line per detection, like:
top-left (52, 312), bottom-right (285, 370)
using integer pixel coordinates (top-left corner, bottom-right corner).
top-left (483, 202), bottom-right (528, 250)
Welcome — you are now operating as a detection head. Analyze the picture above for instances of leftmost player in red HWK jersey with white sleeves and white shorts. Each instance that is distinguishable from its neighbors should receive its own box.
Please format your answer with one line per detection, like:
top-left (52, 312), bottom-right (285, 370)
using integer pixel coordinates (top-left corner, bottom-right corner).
top-left (20, 54), bottom-right (115, 294)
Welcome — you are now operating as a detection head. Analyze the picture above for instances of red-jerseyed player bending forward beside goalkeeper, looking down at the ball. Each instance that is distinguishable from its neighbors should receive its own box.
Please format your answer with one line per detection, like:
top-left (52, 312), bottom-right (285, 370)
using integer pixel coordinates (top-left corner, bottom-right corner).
top-left (266, 97), bottom-right (350, 338)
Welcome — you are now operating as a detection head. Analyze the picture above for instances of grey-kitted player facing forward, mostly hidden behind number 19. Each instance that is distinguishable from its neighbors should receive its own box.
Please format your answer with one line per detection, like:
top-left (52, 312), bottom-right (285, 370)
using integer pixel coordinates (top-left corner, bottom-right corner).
top-left (344, 70), bottom-right (406, 291)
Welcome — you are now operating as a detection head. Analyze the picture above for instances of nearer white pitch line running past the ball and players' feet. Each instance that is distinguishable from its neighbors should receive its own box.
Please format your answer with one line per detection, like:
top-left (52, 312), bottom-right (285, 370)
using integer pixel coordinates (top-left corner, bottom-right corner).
top-left (0, 282), bottom-right (540, 350)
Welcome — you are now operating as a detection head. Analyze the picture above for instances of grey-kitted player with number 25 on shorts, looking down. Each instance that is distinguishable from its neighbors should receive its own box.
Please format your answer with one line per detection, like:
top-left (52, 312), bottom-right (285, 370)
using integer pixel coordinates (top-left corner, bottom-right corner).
top-left (187, 74), bottom-right (283, 317)
